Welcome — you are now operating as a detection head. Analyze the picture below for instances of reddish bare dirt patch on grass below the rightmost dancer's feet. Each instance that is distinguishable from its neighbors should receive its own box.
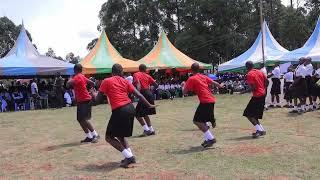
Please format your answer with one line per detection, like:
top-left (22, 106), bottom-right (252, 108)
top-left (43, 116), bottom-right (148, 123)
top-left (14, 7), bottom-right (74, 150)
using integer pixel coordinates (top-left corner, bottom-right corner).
top-left (225, 143), bottom-right (272, 155)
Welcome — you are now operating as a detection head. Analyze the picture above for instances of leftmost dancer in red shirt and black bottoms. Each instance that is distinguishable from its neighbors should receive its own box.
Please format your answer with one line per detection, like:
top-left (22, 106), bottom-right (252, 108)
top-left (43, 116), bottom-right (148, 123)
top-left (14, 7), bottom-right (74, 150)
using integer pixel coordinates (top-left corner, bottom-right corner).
top-left (67, 64), bottom-right (100, 143)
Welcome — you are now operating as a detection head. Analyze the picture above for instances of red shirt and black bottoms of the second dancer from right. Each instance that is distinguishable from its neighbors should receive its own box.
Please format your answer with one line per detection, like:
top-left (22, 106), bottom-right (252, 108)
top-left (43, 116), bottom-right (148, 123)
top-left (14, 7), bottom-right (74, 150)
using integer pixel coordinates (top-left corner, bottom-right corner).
top-left (185, 73), bottom-right (216, 124)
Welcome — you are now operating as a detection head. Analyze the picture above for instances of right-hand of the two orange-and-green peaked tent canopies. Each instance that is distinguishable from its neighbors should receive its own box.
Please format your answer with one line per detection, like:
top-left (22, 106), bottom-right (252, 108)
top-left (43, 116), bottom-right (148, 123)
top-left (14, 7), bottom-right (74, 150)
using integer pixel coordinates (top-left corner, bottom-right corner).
top-left (138, 32), bottom-right (212, 71)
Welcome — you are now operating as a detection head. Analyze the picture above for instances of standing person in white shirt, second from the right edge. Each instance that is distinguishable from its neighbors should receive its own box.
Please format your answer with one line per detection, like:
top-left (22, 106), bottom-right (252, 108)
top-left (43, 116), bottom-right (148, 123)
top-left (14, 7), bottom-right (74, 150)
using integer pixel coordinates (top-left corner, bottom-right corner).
top-left (304, 57), bottom-right (314, 111)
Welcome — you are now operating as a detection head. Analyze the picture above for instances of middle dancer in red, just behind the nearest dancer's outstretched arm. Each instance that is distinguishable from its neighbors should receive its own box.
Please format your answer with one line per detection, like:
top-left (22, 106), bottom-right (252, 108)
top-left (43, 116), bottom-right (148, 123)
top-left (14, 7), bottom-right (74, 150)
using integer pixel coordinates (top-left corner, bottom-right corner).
top-left (133, 64), bottom-right (158, 136)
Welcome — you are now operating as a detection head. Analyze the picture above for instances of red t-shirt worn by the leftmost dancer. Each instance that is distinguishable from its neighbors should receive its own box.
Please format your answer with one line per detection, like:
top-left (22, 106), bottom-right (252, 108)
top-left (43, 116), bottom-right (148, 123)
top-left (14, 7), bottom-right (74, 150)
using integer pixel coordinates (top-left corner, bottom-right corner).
top-left (72, 73), bottom-right (92, 102)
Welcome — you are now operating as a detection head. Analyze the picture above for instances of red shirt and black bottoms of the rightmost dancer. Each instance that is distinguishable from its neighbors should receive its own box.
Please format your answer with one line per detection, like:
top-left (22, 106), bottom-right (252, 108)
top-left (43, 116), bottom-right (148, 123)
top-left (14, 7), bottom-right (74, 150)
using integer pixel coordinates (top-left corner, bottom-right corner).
top-left (243, 69), bottom-right (267, 119)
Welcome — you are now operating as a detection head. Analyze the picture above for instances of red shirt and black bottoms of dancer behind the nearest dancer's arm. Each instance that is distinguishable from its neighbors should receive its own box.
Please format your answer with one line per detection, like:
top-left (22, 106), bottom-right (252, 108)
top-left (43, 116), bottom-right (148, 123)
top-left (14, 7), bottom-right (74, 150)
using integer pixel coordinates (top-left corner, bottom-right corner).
top-left (133, 72), bottom-right (156, 118)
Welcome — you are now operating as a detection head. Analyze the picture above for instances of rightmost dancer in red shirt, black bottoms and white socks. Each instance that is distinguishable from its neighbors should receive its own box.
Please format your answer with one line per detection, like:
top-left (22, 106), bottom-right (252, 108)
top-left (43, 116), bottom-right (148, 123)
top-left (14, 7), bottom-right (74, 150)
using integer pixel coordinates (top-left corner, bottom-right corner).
top-left (243, 61), bottom-right (268, 138)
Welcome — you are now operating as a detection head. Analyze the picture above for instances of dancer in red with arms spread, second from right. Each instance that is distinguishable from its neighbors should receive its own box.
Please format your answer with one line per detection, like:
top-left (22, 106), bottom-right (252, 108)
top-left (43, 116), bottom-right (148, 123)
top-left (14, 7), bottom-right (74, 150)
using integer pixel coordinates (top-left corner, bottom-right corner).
top-left (182, 63), bottom-right (222, 148)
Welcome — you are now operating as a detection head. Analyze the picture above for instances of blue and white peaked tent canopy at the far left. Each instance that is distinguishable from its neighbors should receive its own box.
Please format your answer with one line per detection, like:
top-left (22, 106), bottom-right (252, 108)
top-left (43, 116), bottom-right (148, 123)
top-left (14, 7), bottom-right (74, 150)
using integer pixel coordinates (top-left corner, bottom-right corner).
top-left (0, 25), bottom-right (74, 77)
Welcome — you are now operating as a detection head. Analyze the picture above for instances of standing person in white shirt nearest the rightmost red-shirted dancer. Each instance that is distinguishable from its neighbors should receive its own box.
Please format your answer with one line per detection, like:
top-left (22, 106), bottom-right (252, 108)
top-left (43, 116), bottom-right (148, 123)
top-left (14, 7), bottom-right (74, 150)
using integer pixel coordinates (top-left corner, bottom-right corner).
top-left (268, 62), bottom-right (281, 108)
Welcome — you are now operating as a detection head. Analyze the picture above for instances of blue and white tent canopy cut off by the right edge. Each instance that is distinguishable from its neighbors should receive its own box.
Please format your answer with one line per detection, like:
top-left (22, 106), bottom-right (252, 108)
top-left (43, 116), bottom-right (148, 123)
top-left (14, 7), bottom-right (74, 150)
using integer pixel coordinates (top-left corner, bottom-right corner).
top-left (279, 19), bottom-right (320, 62)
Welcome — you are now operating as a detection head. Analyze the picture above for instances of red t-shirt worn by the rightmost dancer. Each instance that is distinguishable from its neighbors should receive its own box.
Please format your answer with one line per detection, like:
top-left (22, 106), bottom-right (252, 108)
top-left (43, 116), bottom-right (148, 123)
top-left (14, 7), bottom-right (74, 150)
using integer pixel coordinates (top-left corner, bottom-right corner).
top-left (247, 69), bottom-right (267, 97)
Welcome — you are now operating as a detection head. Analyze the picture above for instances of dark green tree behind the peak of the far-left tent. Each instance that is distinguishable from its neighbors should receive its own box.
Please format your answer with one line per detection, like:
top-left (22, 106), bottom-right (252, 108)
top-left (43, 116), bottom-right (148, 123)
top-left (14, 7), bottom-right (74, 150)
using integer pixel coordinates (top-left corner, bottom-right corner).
top-left (0, 17), bottom-right (32, 58)
